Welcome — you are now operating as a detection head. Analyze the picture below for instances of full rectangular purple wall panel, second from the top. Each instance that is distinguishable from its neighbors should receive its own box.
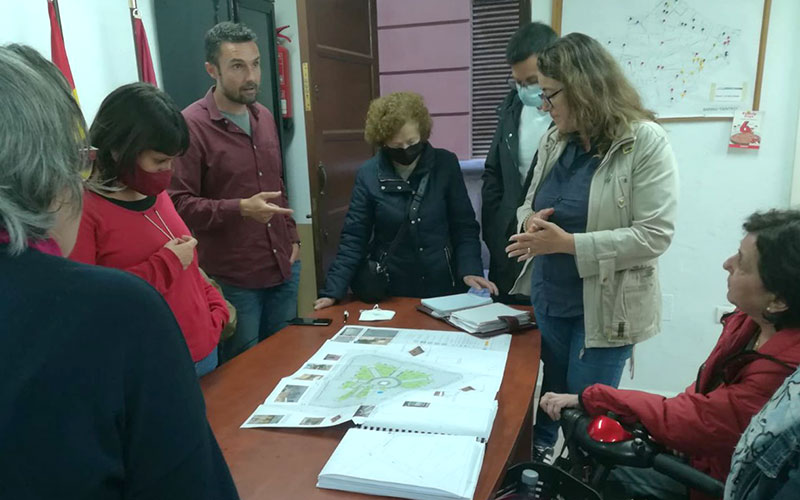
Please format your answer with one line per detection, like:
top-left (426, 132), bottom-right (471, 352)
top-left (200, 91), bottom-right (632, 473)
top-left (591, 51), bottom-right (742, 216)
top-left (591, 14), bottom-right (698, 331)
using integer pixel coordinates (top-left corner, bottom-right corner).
top-left (378, 22), bottom-right (471, 73)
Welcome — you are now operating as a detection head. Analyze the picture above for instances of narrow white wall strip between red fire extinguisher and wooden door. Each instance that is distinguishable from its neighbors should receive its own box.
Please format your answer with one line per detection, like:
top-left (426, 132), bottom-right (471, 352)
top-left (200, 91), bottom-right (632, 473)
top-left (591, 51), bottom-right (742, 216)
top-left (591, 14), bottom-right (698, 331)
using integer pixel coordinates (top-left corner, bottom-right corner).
top-left (275, 0), bottom-right (311, 219)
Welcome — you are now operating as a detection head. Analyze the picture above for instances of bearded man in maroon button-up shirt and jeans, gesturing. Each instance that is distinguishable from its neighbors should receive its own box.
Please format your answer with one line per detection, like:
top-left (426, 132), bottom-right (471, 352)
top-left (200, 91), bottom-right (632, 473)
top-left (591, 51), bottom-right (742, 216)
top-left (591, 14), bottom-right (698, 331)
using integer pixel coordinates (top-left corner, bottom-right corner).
top-left (170, 22), bottom-right (300, 362)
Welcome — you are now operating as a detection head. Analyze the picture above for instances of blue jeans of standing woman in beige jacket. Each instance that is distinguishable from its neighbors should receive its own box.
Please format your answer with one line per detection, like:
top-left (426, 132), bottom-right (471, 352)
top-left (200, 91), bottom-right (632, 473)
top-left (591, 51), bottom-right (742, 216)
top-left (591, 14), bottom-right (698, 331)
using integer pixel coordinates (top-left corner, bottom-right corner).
top-left (533, 313), bottom-right (633, 447)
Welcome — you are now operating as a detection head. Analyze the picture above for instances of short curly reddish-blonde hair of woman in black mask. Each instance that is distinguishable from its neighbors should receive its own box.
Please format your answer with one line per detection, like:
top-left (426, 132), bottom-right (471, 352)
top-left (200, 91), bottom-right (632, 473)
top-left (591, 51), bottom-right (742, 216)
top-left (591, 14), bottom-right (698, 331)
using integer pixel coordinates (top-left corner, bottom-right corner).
top-left (364, 92), bottom-right (433, 146)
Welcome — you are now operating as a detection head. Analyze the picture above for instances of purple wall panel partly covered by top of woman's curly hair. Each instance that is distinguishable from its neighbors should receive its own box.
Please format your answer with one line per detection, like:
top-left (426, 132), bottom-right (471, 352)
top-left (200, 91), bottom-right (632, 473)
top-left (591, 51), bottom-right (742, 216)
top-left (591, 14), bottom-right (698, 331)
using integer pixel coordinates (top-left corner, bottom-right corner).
top-left (381, 70), bottom-right (470, 113)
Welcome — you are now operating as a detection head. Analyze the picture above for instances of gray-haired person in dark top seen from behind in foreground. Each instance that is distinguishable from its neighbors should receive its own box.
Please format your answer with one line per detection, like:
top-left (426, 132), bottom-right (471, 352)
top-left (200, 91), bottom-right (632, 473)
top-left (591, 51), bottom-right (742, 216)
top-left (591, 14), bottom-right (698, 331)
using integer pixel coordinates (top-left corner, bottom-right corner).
top-left (0, 45), bottom-right (238, 500)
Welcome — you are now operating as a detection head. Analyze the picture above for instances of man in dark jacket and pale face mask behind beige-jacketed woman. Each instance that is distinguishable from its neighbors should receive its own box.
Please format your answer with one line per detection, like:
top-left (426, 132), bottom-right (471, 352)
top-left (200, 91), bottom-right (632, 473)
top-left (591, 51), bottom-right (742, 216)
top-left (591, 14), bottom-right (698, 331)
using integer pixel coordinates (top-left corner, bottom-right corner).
top-left (481, 23), bottom-right (557, 305)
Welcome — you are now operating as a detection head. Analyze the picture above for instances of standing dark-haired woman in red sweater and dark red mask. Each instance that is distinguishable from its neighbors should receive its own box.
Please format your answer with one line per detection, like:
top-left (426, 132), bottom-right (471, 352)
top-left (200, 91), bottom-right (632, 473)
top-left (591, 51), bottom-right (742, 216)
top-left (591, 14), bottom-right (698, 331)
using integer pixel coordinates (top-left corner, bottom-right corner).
top-left (70, 83), bottom-right (228, 376)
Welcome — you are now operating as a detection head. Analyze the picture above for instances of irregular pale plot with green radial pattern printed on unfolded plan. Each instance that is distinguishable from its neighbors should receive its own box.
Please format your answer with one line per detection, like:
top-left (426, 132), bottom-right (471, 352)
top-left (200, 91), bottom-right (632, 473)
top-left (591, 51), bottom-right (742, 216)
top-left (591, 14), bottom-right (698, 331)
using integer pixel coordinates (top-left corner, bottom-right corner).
top-left (309, 354), bottom-right (463, 408)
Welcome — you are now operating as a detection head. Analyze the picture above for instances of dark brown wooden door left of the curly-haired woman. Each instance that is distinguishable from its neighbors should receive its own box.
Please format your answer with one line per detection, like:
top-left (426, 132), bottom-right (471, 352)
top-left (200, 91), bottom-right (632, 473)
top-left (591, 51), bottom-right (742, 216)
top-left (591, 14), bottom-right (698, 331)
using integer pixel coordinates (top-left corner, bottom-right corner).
top-left (297, 0), bottom-right (378, 287)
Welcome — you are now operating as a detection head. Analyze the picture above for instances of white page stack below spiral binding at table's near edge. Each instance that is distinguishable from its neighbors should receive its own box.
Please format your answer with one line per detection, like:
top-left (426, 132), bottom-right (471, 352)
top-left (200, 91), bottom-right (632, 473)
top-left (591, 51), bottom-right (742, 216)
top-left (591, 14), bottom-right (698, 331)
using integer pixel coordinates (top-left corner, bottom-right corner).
top-left (317, 428), bottom-right (485, 500)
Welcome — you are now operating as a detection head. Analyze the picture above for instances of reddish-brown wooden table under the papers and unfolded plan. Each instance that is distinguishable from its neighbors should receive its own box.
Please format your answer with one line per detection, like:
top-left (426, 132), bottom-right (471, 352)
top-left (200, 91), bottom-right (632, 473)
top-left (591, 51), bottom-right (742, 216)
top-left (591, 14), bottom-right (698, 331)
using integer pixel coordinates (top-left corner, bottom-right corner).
top-left (200, 298), bottom-right (539, 500)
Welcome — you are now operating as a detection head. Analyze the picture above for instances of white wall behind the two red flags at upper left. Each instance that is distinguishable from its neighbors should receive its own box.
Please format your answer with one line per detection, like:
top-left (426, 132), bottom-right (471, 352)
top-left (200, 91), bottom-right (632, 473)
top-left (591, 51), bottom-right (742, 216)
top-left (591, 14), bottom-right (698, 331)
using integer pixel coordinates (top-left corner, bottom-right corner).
top-left (0, 0), bottom-right (161, 123)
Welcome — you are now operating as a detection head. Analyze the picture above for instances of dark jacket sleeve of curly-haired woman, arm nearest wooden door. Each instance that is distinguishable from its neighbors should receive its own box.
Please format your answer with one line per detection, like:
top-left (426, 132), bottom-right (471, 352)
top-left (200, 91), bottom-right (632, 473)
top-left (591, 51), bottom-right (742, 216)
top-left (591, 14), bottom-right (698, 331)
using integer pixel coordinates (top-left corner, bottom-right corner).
top-left (319, 163), bottom-right (375, 300)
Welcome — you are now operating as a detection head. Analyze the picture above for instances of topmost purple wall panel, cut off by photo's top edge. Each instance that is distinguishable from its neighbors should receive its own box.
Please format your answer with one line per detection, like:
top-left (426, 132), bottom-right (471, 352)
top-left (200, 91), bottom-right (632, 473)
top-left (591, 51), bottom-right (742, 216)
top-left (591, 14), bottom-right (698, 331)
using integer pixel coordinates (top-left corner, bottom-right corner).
top-left (377, 0), bottom-right (472, 28)
